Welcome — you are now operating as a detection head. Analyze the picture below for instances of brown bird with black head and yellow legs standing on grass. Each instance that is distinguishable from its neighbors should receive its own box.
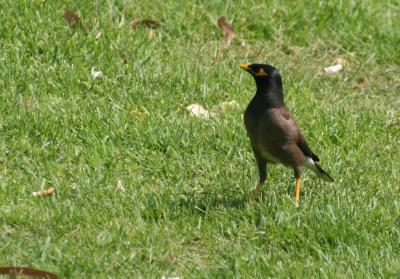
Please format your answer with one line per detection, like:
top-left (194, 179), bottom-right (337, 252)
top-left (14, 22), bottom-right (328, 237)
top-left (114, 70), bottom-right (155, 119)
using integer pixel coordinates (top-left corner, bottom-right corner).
top-left (239, 64), bottom-right (334, 205)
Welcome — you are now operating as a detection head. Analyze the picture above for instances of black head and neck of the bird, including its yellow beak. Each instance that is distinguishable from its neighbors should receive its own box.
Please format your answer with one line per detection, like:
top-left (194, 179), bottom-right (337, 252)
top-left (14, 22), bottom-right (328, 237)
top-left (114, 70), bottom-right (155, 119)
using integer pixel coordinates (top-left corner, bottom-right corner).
top-left (239, 64), bottom-right (283, 105)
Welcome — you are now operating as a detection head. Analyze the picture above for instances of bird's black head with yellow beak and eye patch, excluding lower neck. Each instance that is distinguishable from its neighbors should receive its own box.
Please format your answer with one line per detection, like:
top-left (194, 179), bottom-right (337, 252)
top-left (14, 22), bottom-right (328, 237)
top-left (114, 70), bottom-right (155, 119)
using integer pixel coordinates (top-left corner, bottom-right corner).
top-left (239, 64), bottom-right (282, 93)
